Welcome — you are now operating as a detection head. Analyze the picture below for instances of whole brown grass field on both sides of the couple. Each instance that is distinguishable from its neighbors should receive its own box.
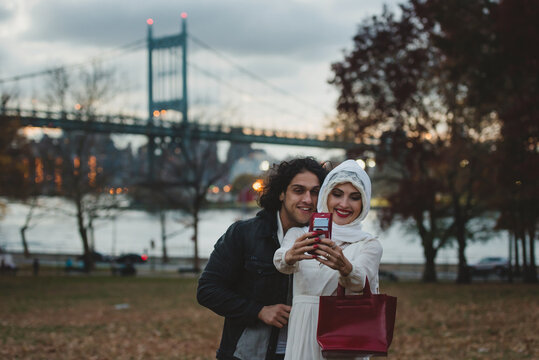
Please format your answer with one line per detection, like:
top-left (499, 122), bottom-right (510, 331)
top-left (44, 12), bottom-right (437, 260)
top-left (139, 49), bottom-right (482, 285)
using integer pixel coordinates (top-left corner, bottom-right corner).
top-left (0, 276), bottom-right (539, 360)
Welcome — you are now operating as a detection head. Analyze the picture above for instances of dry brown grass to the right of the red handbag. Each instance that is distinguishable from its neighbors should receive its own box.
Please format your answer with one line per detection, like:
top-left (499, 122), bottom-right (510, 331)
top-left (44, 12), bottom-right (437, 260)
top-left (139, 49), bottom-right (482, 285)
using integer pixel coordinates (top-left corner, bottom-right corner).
top-left (384, 283), bottom-right (539, 360)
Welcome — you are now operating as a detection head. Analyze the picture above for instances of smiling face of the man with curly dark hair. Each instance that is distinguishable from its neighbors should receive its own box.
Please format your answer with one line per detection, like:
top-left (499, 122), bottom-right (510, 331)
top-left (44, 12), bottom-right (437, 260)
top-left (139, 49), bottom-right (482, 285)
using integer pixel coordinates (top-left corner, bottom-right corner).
top-left (280, 171), bottom-right (320, 233)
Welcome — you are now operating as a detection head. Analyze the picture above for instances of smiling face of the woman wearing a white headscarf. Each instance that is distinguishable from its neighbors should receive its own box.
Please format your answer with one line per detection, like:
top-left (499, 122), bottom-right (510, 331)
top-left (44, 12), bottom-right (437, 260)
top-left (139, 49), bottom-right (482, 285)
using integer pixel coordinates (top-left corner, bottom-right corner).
top-left (328, 183), bottom-right (363, 225)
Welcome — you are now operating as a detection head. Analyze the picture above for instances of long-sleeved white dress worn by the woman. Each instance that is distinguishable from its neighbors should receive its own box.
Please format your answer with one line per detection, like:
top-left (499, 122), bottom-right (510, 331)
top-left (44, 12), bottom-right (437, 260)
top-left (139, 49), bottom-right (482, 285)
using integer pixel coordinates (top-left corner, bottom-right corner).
top-left (273, 228), bottom-right (382, 360)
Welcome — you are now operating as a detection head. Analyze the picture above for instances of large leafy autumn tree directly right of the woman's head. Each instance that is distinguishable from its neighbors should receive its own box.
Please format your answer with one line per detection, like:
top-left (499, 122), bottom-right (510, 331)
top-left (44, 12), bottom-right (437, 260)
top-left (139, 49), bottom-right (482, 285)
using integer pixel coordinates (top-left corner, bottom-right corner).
top-left (330, 3), bottom-right (500, 282)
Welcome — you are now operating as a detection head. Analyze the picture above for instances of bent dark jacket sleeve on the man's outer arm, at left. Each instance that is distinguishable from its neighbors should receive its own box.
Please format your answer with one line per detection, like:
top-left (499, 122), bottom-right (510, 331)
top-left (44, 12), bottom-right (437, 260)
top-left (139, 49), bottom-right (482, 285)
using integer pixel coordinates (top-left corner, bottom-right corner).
top-left (197, 223), bottom-right (263, 324)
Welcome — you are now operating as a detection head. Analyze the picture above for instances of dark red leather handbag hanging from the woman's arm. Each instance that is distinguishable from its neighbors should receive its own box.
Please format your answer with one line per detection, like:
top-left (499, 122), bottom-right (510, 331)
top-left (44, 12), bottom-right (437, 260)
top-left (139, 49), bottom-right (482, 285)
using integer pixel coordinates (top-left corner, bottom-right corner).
top-left (316, 279), bottom-right (397, 358)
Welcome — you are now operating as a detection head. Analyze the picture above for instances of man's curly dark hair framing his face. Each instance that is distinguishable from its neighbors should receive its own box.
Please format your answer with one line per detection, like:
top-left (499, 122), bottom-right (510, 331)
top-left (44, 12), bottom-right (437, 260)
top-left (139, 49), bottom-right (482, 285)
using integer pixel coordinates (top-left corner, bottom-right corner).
top-left (258, 157), bottom-right (327, 212)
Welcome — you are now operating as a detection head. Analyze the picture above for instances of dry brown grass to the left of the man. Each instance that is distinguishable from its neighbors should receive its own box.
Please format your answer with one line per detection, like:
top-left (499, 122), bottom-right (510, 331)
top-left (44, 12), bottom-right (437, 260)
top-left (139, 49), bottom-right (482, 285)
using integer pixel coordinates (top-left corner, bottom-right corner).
top-left (0, 276), bottom-right (222, 359)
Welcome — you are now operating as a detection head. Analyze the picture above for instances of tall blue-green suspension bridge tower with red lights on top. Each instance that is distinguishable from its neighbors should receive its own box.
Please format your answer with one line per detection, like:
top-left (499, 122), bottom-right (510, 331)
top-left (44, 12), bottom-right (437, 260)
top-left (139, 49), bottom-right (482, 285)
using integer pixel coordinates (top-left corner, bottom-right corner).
top-left (147, 13), bottom-right (189, 181)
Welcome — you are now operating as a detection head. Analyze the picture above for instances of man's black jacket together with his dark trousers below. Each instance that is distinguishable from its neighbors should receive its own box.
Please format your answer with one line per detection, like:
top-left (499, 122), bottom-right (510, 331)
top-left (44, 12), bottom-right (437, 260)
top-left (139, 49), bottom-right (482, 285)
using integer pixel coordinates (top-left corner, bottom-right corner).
top-left (197, 210), bottom-right (288, 359)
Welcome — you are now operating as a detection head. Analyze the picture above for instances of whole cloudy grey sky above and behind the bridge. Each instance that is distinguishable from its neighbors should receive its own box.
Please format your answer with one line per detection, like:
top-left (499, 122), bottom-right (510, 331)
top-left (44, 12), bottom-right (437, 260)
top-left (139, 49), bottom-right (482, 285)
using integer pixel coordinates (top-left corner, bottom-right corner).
top-left (0, 0), bottom-right (400, 160)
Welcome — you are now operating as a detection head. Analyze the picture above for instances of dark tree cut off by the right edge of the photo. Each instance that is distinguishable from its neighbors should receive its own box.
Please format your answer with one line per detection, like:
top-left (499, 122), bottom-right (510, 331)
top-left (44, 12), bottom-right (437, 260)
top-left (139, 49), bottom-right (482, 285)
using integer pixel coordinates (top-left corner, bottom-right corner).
top-left (495, 0), bottom-right (539, 283)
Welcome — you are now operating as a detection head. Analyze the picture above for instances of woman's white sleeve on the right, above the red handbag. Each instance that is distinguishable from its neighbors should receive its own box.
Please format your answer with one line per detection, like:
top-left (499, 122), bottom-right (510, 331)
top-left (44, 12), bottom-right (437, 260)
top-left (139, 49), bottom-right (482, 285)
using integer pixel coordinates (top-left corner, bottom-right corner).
top-left (339, 239), bottom-right (383, 294)
